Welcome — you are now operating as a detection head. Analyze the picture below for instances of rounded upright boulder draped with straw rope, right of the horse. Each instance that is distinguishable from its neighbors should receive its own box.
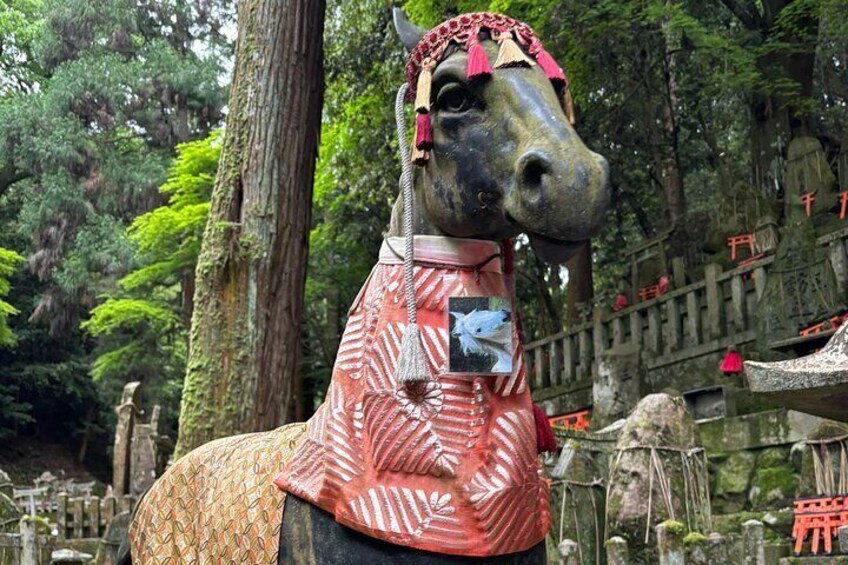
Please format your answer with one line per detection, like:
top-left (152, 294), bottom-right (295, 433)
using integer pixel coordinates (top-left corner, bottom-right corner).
top-left (607, 394), bottom-right (696, 562)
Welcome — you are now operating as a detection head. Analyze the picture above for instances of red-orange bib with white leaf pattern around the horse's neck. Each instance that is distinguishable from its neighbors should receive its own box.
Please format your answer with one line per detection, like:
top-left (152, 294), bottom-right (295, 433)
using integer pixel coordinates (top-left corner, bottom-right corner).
top-left (276, 236), bottom-right (551, 556)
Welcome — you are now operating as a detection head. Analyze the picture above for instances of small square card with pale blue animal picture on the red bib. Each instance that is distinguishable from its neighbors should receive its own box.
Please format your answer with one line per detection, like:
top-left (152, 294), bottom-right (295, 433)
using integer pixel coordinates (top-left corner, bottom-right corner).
top-left (448, 296), bottom-right (513, 374)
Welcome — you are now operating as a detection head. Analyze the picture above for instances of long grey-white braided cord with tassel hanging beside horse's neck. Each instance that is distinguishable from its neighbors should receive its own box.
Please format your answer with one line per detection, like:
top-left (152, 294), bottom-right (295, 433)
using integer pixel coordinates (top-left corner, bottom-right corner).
top-left (395, 83), bottom-right (430, 385)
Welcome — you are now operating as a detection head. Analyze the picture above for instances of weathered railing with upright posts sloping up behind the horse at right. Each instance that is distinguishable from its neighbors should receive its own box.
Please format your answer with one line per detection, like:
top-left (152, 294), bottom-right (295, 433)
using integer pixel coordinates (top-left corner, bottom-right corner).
top-left (524, 228), bottom-right (848, 390)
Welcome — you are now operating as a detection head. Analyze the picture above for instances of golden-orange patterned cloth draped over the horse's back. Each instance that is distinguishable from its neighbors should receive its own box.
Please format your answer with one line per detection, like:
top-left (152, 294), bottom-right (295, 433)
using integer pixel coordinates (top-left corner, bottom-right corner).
top-left (129, 424), bottom-right (306, 565)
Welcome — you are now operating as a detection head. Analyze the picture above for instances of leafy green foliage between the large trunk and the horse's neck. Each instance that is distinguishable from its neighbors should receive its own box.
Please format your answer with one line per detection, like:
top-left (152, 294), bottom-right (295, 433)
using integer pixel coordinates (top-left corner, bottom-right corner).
top-left (303, 0), bottom-right (403, 408)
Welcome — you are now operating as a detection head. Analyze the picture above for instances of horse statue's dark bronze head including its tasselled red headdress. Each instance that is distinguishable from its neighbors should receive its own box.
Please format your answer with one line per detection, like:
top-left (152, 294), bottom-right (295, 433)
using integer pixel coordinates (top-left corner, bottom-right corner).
top-left (390, 8), bottom-right (610, 262)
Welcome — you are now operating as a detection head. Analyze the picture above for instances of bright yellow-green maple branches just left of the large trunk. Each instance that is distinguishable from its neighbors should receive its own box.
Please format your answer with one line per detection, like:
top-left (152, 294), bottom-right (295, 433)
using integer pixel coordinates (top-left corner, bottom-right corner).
top-left (82, 131), bottom-right (221, 432)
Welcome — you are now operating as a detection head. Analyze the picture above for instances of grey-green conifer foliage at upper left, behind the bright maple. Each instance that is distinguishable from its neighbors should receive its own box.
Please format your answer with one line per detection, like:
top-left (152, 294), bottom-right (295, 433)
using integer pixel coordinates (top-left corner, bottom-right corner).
top-left (0, 0), bottom-right (229, 334)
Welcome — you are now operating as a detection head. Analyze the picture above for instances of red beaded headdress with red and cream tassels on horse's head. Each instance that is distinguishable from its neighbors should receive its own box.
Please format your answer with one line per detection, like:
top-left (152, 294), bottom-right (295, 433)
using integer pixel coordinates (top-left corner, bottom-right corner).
top-left (406, 12), bottom-right (571, 164)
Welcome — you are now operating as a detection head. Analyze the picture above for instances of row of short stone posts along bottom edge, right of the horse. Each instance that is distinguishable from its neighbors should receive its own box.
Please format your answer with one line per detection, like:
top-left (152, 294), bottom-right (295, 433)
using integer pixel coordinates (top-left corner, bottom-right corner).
top-left (559, 520), bottom-right (767, 565)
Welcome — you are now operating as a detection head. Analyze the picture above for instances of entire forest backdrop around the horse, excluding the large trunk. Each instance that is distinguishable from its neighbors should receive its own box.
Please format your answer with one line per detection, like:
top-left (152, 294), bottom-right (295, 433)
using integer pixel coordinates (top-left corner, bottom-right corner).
top-left (0, 0), bottom-right (848, 480)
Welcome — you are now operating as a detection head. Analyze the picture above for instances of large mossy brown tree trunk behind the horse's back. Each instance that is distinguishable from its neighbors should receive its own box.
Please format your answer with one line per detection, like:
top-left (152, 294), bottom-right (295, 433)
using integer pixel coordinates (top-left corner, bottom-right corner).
top-left (177, 0), bottom-right (325, 455)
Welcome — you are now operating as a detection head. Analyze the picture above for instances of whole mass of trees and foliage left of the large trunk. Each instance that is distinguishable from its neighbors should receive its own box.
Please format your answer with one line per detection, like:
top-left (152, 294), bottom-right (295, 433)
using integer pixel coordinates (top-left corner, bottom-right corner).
top-left (0, 0), bottom-right (233, 453)
